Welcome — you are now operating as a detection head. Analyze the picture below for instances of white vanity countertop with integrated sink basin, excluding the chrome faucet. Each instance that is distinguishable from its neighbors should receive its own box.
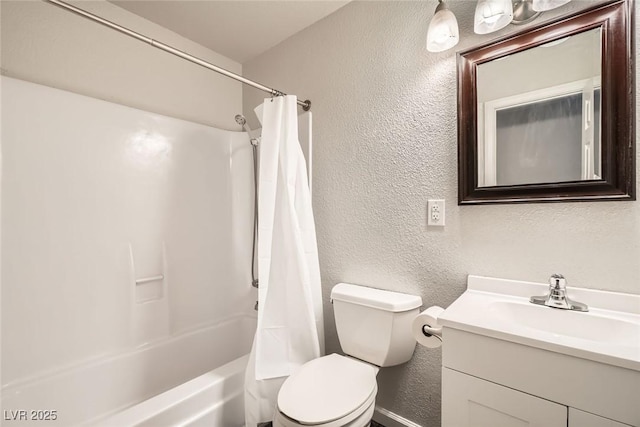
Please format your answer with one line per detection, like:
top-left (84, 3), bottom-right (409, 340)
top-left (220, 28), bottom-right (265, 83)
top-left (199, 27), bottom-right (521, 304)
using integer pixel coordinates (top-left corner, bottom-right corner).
top-left (440, 276), bottom-right (640, 371)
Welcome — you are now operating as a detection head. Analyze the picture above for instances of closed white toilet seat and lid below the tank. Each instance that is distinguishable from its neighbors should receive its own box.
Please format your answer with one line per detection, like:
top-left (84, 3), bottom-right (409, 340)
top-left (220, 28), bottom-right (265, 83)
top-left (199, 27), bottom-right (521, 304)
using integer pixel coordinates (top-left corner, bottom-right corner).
top-left (278, 354), bottom-right (378, 427)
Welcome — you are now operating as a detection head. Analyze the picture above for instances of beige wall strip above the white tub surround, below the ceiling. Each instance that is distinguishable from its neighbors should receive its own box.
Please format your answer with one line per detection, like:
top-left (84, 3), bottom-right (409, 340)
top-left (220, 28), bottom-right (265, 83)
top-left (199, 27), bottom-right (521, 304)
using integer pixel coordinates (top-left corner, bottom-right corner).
top-left (0, 0), bottom-right (242, 130)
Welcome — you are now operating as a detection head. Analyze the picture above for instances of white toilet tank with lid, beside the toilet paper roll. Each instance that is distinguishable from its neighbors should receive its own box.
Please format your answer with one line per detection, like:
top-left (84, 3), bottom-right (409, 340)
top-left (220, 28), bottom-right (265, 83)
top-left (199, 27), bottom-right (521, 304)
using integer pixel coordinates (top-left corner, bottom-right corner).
top-left (331, 283), bottom-right (422, 367)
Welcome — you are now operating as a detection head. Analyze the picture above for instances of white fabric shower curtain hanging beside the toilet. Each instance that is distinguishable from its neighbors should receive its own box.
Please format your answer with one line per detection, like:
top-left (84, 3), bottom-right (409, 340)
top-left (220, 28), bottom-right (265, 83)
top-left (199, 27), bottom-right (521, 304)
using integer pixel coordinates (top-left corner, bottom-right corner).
top-left (245, 95), bottom-right (324, 427)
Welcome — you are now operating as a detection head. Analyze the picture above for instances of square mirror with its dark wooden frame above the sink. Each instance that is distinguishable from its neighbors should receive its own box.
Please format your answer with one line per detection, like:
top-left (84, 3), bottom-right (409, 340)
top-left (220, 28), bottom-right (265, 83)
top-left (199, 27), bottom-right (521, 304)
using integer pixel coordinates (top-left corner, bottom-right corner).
top-left (458, 1), bottom-right (635, 204)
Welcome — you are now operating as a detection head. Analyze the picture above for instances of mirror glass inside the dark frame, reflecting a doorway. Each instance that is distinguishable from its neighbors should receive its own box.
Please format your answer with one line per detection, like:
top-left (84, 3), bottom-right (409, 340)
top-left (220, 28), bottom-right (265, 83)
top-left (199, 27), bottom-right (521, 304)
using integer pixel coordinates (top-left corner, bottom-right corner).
top-left (477, 28), bottom-right (602, 187)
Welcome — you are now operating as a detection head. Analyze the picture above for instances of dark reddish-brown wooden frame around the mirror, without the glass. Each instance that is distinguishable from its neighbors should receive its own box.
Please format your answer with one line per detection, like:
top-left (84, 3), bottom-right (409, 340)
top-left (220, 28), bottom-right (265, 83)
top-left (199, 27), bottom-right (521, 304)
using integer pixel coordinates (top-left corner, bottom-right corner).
top-left (458, 0), bottom-right (636, 205)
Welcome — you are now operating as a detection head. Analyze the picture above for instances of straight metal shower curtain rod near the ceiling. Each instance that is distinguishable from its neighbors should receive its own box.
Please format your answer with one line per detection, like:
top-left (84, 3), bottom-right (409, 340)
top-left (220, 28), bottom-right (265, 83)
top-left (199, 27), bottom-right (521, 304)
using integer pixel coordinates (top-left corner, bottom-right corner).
top-left (43, 0), bottom-right (311, 111)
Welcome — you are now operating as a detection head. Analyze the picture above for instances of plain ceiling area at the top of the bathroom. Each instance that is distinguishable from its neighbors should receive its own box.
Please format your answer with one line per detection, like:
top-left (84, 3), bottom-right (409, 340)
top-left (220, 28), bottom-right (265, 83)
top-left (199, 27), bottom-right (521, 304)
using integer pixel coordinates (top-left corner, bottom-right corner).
top-left (110, 0), bottom-right (349, 64)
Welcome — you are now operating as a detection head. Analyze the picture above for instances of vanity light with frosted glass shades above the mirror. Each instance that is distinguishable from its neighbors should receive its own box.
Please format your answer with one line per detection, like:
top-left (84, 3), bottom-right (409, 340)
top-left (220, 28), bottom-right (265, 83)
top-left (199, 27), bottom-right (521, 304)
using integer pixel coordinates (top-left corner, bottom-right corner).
top-left (427, 0), bottom-right (571, 52)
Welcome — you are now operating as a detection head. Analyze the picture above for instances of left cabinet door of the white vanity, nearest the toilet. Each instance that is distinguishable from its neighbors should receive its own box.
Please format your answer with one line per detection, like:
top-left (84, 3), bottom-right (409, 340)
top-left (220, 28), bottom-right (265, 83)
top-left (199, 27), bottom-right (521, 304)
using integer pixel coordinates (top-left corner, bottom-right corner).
top-left (442, 368), bottom-right (567, 427)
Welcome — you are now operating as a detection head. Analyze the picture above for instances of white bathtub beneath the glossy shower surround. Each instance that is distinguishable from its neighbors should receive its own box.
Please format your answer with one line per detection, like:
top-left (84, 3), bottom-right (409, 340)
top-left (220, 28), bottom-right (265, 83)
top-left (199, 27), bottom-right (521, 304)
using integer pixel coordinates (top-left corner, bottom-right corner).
top-left (2, 315), bottom-right (256, 427)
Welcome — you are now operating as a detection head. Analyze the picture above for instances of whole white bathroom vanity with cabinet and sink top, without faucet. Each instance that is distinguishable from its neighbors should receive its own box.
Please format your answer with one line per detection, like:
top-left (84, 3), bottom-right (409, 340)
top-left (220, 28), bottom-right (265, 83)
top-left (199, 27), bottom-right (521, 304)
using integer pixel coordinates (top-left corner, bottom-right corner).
top-left (440, 276), bottom-right (640, 427)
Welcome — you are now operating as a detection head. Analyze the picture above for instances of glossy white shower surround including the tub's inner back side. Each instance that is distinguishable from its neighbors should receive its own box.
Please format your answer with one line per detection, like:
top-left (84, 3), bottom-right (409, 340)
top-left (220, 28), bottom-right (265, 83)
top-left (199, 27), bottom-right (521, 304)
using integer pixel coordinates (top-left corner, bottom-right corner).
top-left (1, 77), bottom-right (255, 426)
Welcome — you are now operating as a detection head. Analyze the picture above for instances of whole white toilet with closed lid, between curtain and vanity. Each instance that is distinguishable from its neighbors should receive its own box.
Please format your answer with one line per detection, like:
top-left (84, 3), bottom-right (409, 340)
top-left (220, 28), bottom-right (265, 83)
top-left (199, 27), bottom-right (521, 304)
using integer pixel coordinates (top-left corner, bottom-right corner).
top-left (273, 283), bottom-right (422, 427)
